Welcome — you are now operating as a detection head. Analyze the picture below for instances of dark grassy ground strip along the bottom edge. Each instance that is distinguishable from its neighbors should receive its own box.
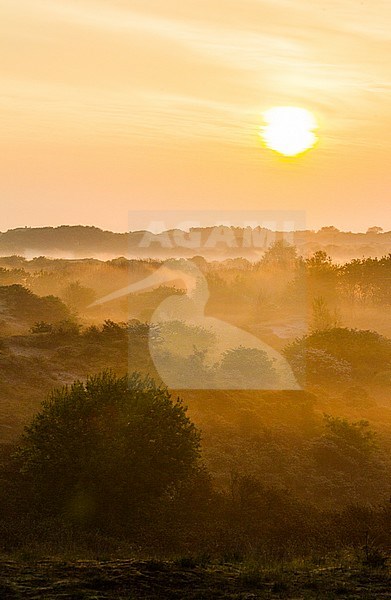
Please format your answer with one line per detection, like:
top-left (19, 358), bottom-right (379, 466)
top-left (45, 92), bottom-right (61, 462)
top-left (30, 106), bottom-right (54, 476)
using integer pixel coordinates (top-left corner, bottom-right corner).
top-left (0, 560), bottom-right (391, 600)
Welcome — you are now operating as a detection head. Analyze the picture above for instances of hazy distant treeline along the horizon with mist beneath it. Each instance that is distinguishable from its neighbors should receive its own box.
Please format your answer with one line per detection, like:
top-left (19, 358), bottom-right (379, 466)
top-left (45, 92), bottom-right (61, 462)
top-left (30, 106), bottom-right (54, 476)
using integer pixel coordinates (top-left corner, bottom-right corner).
top-left (0, 225), bottom-right (391, 260)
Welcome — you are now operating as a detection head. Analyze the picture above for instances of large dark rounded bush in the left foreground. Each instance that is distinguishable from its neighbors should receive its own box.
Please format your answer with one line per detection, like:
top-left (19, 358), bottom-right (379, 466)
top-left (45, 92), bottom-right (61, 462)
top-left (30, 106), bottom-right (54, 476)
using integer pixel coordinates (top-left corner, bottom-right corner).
top-left (18, 371), bottom-right (200, 527)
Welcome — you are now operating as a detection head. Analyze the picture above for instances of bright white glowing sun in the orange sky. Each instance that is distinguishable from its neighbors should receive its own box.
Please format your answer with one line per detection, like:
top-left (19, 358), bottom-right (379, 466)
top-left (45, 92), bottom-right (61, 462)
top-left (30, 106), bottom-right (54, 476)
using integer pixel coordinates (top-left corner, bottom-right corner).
top-left (260, 106), bottom-right (318, 156)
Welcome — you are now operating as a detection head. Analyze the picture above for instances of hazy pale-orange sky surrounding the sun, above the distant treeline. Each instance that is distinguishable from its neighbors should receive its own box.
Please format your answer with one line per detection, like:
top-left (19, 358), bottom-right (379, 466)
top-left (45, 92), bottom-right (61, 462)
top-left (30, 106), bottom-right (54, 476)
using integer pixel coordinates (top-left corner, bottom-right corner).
top-left (0, 0), bottom-right (391, 231)
